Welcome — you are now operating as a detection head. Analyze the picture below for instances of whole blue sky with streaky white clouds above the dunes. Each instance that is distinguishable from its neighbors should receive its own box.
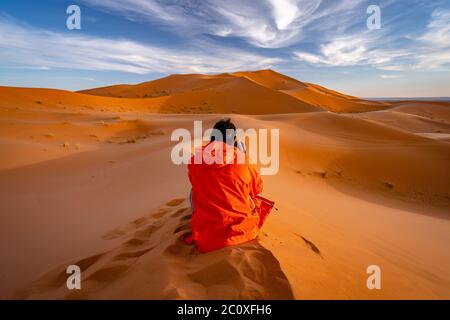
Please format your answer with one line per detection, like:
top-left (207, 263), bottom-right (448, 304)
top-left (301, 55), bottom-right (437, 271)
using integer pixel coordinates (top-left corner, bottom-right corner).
top-left (0, 0), bottom-right (450, 97)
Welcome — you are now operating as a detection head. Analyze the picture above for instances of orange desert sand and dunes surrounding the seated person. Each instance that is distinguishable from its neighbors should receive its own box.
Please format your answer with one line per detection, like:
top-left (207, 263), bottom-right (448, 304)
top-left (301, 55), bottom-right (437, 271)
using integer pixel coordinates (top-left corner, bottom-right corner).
top-left (0, 70), bottom-right (450, 299)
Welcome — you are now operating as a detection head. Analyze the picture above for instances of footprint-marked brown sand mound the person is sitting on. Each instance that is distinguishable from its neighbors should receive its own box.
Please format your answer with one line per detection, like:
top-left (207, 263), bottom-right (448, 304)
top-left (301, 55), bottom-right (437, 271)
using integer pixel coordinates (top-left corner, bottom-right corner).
top-left (16, 199), bottom-right (293, 299)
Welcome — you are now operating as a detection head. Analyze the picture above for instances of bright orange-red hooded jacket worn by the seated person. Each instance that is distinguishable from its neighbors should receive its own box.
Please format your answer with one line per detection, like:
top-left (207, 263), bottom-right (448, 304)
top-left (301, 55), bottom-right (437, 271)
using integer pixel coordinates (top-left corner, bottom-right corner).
top-left (187, 141), bottom-right (273, 252)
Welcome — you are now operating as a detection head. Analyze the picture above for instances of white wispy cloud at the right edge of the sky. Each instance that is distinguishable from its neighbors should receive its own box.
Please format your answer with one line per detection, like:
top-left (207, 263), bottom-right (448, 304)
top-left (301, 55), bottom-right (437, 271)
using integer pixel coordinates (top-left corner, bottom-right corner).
top-left (293, 9), bottom-right (450, 71)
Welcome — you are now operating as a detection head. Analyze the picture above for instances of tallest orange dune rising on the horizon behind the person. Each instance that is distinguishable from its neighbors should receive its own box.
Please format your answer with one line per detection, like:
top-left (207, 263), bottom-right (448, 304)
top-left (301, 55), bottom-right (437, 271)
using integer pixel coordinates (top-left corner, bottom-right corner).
top-left (80, 70), bottom-right (390, 114)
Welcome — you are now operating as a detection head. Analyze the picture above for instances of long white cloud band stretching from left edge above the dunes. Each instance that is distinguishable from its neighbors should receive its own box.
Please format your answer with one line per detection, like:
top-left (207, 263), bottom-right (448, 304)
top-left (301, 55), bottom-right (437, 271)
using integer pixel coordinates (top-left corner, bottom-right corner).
top-left (0, 18), bottom-right (279, 74)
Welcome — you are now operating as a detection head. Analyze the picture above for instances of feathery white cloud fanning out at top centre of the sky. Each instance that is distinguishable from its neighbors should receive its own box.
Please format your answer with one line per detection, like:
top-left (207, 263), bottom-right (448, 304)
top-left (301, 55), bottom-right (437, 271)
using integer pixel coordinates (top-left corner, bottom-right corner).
top-left (82, 0), bottom-right (362, 48)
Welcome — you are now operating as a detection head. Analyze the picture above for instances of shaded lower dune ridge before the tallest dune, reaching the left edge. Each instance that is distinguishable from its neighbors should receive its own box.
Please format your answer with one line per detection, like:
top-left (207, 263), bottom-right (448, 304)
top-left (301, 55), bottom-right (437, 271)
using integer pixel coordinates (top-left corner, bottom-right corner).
top-left (0, 77), bottom-right (316, 114)
